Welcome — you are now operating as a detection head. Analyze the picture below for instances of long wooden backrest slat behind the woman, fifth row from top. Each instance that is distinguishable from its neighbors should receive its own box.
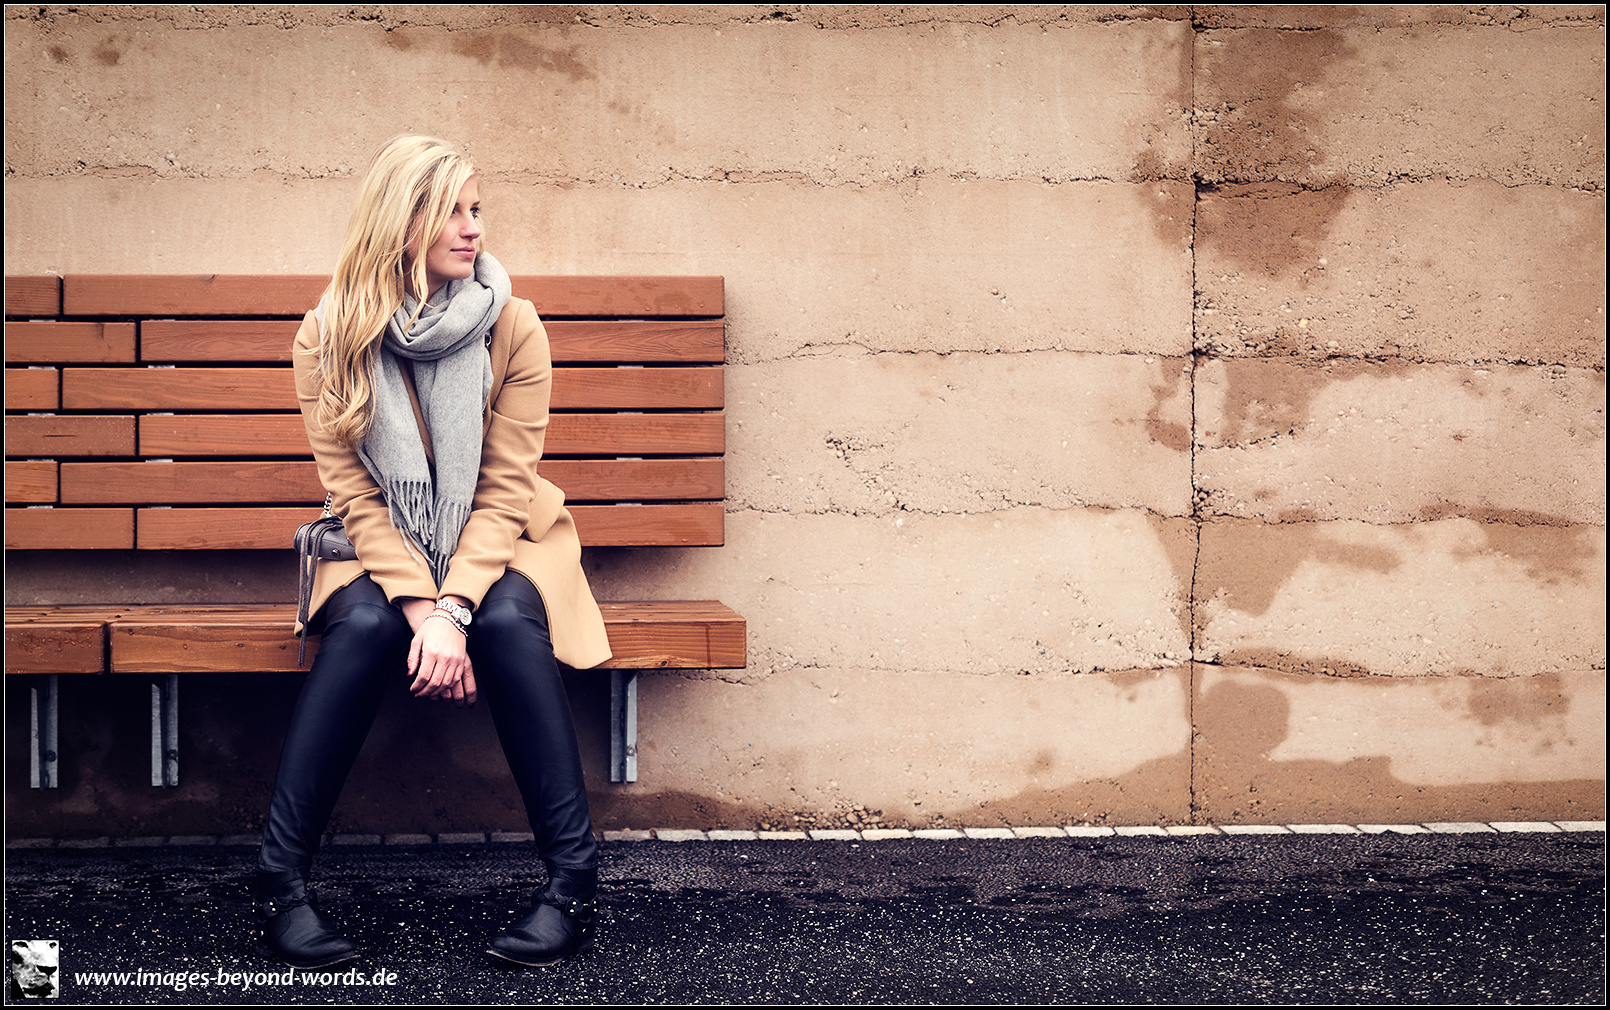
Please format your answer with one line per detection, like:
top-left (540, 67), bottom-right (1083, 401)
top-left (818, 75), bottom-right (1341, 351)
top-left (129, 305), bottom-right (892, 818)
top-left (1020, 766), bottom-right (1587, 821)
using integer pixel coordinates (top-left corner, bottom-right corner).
top-left (58, 456), bottom-right (725, 504)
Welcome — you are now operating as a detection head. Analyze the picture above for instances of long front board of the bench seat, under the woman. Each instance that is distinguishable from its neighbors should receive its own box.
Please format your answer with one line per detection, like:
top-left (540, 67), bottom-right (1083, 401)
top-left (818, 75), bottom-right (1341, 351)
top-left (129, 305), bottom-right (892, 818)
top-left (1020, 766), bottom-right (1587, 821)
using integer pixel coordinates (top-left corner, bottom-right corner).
top-left (103, 601), bottom-right (747, 673)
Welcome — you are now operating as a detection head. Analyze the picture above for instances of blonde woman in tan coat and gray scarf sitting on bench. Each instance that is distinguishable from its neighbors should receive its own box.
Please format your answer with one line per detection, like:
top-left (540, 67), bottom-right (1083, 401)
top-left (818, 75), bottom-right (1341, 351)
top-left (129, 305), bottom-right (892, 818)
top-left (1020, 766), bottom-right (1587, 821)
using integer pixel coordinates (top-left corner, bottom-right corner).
top-left (253, 137), bottom-right (610, 968)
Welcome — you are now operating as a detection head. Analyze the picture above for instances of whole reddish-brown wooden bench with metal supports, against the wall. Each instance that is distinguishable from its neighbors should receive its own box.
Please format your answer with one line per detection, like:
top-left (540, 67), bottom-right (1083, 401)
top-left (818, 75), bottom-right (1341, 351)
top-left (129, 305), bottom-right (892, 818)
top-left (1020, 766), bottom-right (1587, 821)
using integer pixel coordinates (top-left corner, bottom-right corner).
top-left (5, 275), bottom-right (745, 786)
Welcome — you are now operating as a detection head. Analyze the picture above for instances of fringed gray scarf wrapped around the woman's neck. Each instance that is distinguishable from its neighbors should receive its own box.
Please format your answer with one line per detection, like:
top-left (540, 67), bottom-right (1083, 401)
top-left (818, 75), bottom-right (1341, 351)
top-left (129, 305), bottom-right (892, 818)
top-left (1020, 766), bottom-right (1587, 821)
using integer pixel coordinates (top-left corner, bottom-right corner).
top-left (316, 253), bottom-right (510, 586)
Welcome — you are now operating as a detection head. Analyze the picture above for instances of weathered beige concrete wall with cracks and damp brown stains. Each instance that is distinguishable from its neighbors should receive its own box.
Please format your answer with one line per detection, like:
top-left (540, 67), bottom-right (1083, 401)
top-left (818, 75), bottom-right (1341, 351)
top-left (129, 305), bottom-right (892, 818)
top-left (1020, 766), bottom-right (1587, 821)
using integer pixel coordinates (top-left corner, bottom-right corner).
top-left (5, 5), bottom-right (1605, 833)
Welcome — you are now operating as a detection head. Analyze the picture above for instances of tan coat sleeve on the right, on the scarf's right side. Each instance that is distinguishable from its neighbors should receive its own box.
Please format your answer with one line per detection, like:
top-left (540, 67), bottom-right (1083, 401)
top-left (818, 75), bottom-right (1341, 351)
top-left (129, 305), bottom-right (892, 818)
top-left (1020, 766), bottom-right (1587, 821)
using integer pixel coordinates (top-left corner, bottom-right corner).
top-left (441, 298), bottom-right (564, 606)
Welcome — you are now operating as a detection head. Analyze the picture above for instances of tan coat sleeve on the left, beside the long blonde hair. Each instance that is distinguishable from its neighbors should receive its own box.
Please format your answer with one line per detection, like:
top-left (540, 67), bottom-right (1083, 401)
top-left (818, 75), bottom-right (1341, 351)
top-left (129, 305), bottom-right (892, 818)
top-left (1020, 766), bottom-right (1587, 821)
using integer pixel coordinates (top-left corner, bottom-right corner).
top-left (291, 313), bottom-right (436, 601)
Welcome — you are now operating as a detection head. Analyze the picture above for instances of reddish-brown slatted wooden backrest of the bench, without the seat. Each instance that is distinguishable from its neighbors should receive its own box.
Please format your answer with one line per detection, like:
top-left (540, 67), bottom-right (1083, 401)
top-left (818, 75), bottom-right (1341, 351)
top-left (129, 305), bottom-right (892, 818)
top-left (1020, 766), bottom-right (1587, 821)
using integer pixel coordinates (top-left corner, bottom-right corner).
top-left (5, 275), bottom-right (726, 549)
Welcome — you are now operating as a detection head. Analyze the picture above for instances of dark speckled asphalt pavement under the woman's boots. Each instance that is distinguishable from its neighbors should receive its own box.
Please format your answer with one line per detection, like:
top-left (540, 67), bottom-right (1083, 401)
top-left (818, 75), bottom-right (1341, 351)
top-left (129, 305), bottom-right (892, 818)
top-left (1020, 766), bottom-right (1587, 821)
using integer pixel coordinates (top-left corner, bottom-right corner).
top-left (5, 831), bottom-right (1605, 1005)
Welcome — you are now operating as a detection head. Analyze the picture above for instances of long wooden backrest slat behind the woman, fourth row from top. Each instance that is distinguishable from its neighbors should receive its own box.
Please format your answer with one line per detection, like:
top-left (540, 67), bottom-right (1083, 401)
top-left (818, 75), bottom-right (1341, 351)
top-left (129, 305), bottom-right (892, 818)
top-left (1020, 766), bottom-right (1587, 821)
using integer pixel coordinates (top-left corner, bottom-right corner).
top-left (135, 414), bottom-right (726, 456)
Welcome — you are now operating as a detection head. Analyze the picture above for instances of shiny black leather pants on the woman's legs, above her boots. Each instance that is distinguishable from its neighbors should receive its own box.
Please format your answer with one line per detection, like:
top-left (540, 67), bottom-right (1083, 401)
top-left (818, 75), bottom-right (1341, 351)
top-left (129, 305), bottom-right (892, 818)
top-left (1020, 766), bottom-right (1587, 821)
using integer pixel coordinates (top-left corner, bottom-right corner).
top-left (258, 572), bottom-right (597, 873)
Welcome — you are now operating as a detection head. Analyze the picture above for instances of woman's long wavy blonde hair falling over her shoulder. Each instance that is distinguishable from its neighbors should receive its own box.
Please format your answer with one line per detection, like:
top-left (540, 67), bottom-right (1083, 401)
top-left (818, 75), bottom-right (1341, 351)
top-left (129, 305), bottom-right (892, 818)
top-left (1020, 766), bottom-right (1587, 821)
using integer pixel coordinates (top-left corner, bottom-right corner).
top-left (314, 135), bottom-right (475, 448)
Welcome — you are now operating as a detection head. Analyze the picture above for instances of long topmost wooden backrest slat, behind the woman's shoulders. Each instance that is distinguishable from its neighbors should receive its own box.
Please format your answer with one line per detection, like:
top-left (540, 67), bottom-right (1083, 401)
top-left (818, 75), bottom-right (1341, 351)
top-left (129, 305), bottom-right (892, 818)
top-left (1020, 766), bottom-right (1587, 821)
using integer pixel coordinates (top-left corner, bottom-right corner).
top-left (69, 274), bottom-right (726, 317)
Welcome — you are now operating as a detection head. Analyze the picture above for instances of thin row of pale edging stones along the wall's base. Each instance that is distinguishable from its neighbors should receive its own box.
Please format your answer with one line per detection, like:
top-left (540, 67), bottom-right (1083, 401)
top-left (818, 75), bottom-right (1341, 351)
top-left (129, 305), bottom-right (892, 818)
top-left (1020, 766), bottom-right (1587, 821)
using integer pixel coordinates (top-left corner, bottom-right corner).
top-left (5, 820), bottom-right (1605, 849)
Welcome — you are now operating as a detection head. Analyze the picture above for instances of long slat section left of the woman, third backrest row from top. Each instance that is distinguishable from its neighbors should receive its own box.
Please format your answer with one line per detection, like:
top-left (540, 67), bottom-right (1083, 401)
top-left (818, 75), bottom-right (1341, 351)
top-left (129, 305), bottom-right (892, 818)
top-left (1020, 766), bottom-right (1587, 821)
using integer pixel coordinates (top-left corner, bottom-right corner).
top-left (61, 367), bottom-right (296, 411)
